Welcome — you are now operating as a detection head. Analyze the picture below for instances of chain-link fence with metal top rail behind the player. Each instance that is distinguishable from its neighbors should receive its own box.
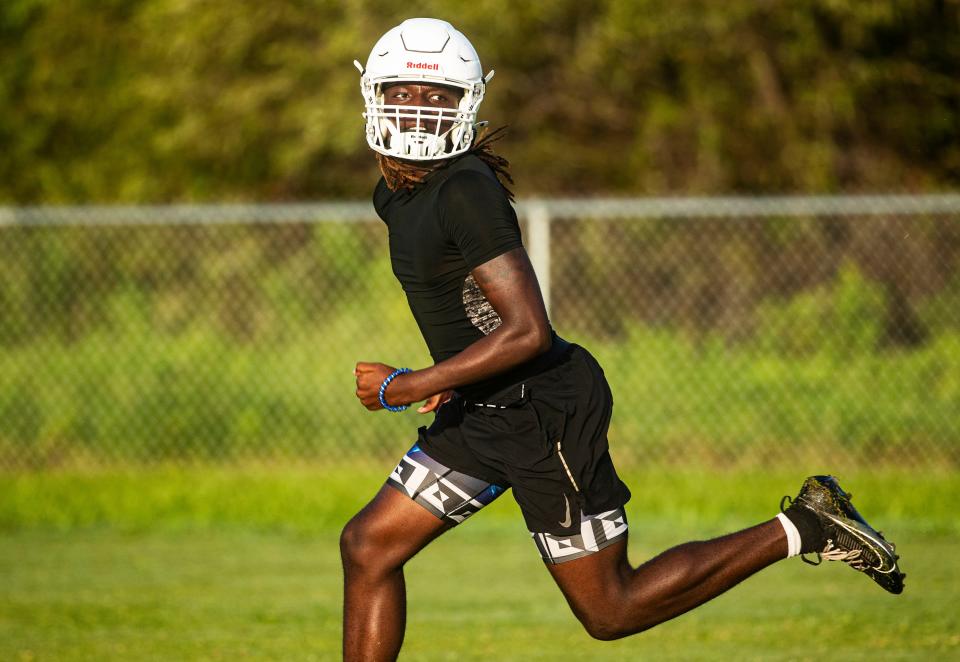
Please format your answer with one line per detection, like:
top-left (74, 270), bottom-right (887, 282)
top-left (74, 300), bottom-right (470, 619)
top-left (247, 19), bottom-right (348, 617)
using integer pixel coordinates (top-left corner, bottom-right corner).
top-left (0, 195), bottom-right (960, 471)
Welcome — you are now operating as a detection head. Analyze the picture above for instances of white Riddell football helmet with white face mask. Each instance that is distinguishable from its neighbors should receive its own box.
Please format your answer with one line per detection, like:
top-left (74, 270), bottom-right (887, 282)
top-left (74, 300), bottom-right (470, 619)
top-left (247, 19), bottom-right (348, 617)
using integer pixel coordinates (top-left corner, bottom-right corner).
top-left (354, 18), bottom-right (493, 161)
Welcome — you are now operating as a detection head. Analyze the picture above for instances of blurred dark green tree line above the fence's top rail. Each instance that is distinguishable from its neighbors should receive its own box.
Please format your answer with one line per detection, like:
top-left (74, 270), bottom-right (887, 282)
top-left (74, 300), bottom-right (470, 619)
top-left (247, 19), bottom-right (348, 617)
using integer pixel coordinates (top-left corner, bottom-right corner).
top-left (0, 0), bottom-right (960, 203)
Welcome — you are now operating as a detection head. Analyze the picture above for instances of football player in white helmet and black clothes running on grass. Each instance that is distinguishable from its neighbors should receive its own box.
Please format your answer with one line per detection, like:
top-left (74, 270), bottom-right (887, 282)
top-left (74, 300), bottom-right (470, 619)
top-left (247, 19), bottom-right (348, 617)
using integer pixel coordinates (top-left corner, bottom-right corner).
top-left (341, 18), bottom-right (903, 661)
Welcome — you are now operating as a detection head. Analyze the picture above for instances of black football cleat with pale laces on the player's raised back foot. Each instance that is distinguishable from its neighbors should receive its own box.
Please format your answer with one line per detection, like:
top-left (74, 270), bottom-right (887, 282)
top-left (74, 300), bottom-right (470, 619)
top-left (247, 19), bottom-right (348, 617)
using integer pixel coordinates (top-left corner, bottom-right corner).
top-left (780, 476), bottom-right (906, 593)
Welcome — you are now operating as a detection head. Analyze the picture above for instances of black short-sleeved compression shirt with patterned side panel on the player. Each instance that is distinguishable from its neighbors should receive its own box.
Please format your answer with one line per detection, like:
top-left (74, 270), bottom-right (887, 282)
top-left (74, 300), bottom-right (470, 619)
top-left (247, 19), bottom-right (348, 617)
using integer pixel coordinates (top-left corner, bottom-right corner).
top-left (373, 155), bottom-right (560, 396)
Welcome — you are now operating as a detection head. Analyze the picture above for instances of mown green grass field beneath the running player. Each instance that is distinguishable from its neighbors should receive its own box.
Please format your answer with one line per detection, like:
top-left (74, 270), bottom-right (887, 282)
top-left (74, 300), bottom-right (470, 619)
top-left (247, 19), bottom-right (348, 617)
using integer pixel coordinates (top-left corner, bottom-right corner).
top-left (0, 467), bottom-right (960, 660)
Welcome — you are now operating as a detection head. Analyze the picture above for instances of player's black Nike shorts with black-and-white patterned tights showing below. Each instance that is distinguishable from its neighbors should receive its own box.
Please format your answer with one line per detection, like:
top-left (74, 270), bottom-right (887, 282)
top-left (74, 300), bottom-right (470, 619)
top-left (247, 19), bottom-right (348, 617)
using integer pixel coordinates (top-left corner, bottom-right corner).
top-left (388, 339), bottom-right (630, 560)
